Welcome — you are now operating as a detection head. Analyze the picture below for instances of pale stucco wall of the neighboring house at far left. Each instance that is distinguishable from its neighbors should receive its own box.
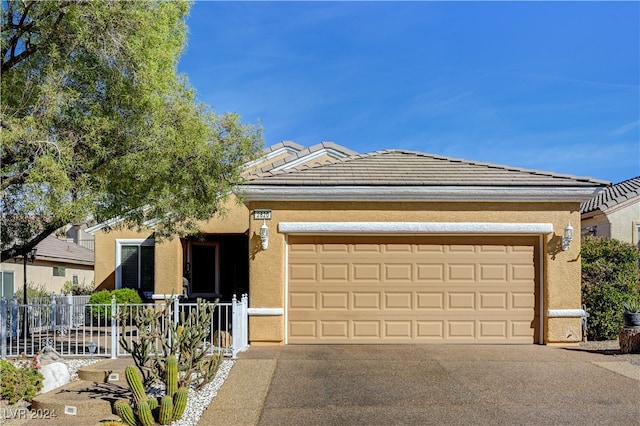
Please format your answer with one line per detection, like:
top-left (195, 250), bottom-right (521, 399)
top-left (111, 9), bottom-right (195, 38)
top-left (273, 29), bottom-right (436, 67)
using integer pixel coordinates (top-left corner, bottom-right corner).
top-left (0, 259), bottom-right (94, 294)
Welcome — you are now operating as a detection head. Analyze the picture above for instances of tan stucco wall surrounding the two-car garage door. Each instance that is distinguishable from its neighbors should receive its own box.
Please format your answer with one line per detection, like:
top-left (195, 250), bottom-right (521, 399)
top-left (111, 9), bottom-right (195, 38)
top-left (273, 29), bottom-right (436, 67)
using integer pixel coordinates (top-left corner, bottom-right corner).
top-left (249, 202), bottom-right (581, 344)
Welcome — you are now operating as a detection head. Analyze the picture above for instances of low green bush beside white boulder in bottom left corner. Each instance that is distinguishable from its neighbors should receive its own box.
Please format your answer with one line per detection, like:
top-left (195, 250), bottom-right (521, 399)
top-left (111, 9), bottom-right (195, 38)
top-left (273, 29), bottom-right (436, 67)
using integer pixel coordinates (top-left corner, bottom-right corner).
top-left (0, 357), bottom-right (44, 404)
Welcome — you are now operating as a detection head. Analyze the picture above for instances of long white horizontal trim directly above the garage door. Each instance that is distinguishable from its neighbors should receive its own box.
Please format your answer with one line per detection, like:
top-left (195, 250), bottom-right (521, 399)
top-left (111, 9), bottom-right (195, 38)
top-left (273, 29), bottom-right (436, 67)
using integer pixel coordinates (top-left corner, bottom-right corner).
top-left (278, 222), bottom-right (553, 235)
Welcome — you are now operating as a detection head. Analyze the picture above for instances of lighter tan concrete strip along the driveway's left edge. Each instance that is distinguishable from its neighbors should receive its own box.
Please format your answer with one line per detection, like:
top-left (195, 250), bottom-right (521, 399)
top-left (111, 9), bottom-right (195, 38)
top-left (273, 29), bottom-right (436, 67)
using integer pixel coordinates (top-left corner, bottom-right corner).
top-left (198, 359), bottom-right (277, 426)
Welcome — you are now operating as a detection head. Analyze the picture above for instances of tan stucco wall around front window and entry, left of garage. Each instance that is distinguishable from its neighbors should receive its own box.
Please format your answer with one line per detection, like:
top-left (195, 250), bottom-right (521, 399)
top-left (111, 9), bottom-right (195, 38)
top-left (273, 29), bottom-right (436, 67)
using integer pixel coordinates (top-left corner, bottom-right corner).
top-left (95, 197), bottom-right (249, 294)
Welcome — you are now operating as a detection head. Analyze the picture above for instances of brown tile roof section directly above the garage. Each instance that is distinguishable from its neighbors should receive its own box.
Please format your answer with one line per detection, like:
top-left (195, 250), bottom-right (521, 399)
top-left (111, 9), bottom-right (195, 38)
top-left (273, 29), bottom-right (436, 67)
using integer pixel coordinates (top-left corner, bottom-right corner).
top-left (247, 150), bottom-right (609, 187)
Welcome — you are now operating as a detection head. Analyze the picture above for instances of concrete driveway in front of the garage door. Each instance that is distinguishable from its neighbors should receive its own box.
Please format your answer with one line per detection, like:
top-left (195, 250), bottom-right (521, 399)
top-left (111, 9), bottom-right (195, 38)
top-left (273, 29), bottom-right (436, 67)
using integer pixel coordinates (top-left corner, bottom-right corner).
top-left (200, 345), bottom-right (640, 426)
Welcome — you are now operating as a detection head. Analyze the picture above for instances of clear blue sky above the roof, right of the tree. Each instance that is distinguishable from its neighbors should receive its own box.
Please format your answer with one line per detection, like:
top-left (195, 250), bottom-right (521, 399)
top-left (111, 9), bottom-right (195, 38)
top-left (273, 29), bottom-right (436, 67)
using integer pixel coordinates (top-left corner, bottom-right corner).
top-left (178, 1), bottom-right (640, 182)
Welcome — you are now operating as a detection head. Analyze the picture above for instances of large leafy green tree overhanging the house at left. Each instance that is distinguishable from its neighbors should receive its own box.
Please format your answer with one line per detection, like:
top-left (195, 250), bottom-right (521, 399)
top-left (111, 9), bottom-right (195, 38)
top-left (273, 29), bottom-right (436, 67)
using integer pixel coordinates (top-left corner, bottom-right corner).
top-left (0, 0), bottom-right (262, 261)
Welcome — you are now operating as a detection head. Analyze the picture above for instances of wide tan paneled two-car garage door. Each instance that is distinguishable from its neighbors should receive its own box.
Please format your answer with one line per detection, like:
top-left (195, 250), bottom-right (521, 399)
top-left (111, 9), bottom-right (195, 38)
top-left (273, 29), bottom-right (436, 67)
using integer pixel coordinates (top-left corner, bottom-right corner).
top-left (287, 236), bottom-right (537, 343)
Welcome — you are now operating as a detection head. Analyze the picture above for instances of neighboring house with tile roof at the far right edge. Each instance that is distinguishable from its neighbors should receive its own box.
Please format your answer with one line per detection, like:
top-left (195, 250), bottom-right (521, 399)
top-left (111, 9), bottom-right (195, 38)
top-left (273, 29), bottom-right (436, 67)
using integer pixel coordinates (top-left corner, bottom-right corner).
top-left (580, 176), bottom-right (640, 248)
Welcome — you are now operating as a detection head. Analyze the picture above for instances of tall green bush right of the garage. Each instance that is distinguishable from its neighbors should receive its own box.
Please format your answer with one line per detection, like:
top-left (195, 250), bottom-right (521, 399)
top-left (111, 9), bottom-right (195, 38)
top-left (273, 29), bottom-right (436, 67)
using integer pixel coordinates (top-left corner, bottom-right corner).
top-left (581, 237), bottom-right (640, 340)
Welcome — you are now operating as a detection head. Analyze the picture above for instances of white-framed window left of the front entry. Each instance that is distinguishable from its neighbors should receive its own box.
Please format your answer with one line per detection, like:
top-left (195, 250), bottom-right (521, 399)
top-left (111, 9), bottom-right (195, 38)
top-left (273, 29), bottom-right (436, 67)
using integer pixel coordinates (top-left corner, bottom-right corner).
top-left (116, 239), bottom-right (155, 292)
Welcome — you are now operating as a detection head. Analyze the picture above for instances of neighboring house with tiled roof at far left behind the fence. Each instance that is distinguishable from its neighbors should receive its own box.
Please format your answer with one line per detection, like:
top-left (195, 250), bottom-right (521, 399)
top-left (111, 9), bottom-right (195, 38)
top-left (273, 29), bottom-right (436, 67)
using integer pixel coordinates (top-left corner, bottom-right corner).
top-left (0, 236), bottom-right (94, 298)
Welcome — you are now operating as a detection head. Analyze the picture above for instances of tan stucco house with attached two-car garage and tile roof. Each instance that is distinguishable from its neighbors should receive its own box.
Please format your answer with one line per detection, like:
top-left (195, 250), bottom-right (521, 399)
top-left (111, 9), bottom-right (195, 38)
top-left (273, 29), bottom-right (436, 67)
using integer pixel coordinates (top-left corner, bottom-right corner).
top-left (88, 143), bottom-right (609, 344)
